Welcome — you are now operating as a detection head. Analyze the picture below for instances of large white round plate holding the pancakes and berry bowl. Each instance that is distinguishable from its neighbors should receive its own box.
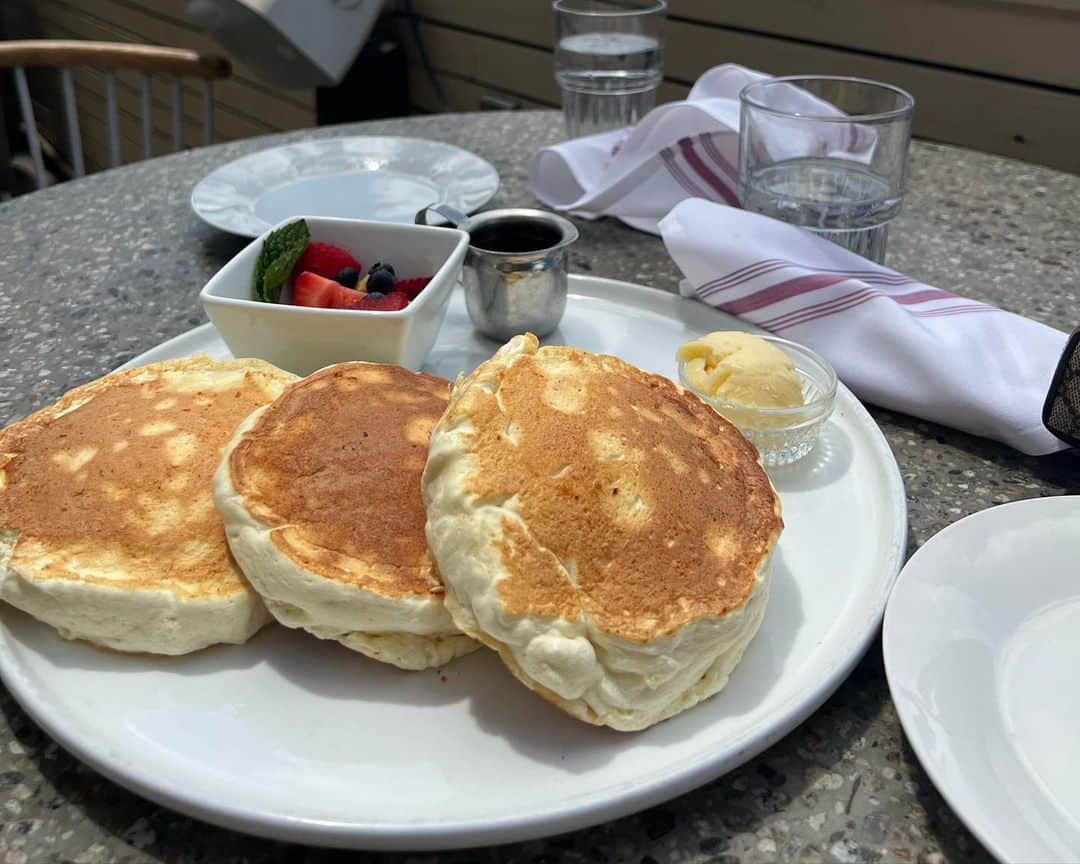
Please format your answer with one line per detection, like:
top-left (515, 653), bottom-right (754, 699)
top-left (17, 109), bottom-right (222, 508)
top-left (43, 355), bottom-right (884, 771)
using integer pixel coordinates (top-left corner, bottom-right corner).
top-left (0, 278), bottom-right (906, 849)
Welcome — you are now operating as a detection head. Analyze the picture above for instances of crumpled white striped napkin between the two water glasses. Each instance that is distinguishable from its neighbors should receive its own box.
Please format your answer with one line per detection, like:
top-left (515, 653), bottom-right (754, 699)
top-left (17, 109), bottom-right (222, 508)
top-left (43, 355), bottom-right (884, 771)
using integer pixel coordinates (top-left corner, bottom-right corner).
top-left (529, 64), bottom-right (875, 234)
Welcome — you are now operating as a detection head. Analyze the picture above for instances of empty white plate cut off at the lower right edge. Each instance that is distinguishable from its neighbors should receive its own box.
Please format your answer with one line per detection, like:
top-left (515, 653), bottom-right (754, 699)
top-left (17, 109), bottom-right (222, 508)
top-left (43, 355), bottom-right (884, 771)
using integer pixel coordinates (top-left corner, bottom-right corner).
top-left (885, 497), bottom-right (1080, 864)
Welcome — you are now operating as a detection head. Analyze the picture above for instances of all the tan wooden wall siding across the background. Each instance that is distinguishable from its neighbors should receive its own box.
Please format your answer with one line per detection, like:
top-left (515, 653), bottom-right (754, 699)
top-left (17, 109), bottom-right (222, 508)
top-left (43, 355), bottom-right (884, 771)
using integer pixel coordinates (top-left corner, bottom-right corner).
top-left (0, 0), bottom-right (1080, 172)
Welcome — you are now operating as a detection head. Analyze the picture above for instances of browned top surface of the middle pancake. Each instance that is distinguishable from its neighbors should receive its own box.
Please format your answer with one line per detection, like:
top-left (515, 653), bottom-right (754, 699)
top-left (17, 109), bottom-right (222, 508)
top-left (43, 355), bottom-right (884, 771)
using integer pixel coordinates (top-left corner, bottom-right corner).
top-left (229, 363), bottom-right (450, 596)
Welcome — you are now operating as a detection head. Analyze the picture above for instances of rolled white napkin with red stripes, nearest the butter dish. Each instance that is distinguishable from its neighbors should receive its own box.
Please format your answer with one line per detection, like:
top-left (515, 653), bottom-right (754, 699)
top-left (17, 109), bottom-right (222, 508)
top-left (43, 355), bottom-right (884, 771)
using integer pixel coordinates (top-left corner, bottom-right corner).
top-left (659, 199), bottom-right (1067, 456)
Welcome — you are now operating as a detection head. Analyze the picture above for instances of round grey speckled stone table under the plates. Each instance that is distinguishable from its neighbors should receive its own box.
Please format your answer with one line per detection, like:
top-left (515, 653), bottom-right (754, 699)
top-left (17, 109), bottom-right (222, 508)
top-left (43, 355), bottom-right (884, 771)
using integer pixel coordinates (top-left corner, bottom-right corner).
top-left (0, 112), bottom-right (1080, 864)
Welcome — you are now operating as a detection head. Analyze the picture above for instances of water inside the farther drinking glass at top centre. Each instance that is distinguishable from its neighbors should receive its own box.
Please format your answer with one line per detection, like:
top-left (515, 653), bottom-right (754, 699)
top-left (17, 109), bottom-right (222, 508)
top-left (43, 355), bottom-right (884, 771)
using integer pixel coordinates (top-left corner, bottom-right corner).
top-left (555, 32), bottom-right (663, 138)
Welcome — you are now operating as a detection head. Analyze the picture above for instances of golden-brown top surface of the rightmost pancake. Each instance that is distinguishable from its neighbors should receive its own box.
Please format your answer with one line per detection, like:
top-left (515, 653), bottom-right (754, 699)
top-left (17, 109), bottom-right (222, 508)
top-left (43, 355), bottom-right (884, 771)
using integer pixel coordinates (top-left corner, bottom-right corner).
top-left (448, 347), bottom-right (783, 642)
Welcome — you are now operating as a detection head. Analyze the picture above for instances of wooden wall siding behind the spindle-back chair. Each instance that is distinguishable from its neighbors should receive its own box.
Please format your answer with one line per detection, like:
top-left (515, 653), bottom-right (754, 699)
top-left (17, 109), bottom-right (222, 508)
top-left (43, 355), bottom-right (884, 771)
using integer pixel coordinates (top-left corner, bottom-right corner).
top-left (0, 0), bottom-right (315, 171)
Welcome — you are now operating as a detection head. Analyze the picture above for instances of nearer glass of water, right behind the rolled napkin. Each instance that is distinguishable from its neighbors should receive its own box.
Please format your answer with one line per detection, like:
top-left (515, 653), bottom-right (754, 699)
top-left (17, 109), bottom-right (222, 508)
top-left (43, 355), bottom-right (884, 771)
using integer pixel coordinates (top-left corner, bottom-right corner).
top-left (739, 77), bottom-right (915, 264)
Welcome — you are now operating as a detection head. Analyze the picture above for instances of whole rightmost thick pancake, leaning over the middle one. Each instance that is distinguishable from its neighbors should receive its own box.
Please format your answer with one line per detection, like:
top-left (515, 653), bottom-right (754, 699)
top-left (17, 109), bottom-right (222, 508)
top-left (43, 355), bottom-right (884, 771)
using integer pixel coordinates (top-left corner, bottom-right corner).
top-left (423, 334), bottom-right (783, 730)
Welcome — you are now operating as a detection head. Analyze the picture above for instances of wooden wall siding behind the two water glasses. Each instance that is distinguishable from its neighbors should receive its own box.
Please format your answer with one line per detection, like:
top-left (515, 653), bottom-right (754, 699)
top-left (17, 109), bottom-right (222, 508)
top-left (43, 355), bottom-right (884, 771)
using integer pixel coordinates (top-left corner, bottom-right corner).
top-left (401, 0), bottom-right (1080, 172)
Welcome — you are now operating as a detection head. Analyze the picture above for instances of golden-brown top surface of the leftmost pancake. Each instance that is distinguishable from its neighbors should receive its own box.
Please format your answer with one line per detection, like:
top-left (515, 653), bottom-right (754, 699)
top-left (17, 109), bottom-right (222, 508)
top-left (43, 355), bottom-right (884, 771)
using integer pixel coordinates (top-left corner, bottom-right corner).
top-left (0, 356), bottom-right (292, 594)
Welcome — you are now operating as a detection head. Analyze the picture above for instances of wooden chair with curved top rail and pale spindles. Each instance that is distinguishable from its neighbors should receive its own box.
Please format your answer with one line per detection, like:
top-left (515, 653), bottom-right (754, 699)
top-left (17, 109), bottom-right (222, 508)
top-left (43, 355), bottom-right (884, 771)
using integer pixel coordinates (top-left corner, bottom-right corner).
top-left (0, 39), bottom-right (231, 189)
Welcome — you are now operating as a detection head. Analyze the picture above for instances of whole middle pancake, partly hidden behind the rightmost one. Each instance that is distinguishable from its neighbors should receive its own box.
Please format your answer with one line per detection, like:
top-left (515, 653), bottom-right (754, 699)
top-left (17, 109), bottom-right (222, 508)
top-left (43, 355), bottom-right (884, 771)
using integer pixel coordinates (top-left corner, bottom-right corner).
top-left (214, 363), bottom-right (478, 670)
